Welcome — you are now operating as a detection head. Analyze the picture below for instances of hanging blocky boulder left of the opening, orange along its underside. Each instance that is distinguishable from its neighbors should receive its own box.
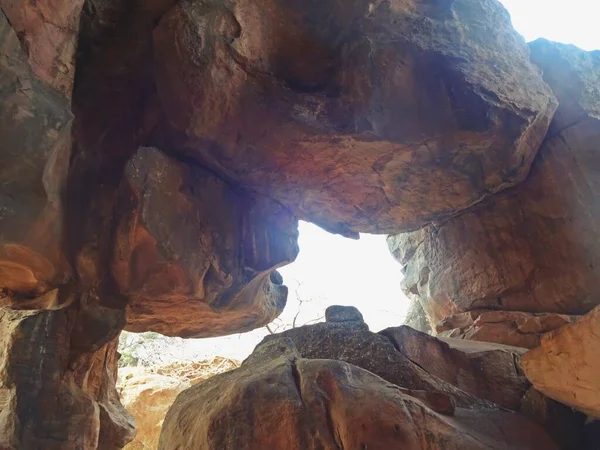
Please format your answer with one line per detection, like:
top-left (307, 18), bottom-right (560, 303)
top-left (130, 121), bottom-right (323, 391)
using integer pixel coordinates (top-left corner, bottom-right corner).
top-left (112, 148), bottom-right (298, 337)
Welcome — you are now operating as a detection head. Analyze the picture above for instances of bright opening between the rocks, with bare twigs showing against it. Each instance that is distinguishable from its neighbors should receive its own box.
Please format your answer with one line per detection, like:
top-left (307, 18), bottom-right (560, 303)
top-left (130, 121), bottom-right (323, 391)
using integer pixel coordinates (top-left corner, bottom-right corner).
top-left (120, 221), bottom-right (409, 366)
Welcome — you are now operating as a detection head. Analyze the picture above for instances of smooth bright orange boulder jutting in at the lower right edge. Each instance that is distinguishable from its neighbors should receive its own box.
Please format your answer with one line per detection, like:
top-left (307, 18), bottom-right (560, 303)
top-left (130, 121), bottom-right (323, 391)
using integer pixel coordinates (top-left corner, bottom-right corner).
top-left (521, 307), bottom-right (600, 418)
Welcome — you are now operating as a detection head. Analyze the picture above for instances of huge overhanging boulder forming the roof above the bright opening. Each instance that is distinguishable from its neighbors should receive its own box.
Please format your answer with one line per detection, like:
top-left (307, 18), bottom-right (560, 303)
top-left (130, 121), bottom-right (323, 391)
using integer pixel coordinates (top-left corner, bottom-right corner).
top-left (154, 0), bottom-right (556, 236)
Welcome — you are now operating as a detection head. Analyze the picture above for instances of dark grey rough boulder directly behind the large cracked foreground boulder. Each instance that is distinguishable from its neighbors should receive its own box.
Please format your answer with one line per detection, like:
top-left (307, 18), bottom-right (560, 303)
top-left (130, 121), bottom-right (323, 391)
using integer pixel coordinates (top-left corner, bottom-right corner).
top-left (263, 322), bottom-right (496, 409)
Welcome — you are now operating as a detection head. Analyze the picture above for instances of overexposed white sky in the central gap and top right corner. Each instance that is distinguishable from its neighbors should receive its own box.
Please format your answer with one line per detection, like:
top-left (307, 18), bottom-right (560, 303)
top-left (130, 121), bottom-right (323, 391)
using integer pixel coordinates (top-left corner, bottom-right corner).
top-left (124, 0), bottom-right (600, 359)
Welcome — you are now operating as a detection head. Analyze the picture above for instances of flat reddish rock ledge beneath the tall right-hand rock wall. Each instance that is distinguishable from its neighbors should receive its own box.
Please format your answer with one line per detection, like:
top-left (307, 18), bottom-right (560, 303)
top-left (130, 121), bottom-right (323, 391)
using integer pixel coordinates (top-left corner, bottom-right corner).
top-left (436, 310), bottom-right (578, 348)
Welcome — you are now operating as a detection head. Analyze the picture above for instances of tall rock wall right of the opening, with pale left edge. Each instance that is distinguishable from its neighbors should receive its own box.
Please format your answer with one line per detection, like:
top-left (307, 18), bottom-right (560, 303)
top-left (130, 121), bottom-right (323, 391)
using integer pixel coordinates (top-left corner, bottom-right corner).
top-left (388, 38), bottom-right (600, 324)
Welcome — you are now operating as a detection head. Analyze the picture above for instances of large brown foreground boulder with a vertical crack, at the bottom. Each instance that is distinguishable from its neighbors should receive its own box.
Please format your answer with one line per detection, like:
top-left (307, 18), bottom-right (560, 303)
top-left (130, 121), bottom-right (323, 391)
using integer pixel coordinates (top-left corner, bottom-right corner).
top-left (158, 339), bottom-right (558, 450)
